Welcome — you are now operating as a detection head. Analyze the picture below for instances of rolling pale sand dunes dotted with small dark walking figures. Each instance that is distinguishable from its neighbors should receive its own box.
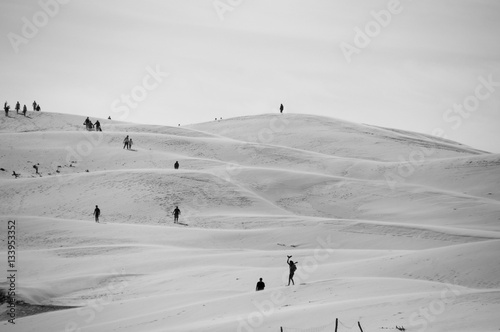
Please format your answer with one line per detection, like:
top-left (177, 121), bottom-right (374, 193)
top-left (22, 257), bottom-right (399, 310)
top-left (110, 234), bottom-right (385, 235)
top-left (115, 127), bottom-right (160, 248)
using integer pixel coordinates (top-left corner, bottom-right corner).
top-left (0, 112), bottom-right (500, 332)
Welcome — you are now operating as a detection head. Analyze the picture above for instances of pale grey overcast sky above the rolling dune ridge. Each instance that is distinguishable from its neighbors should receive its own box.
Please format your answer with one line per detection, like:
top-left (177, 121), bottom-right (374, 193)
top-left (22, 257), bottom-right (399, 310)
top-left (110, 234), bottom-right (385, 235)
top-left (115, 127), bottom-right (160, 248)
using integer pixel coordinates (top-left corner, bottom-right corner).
top-left (0, 0), bottom-right (500, 153)
